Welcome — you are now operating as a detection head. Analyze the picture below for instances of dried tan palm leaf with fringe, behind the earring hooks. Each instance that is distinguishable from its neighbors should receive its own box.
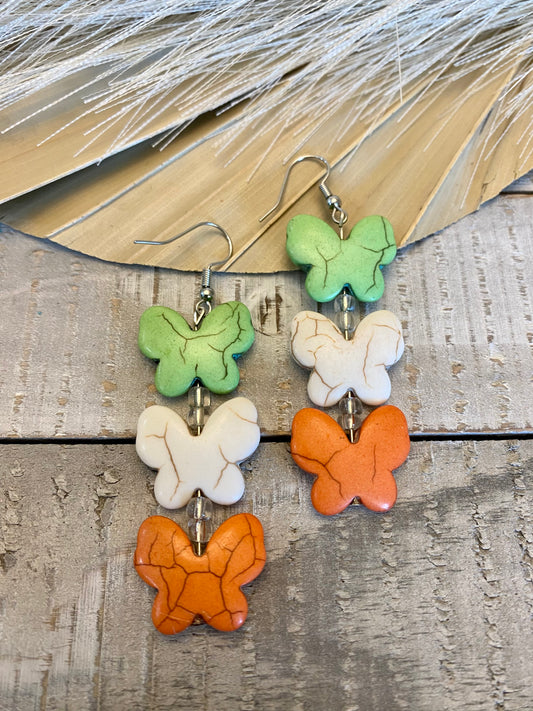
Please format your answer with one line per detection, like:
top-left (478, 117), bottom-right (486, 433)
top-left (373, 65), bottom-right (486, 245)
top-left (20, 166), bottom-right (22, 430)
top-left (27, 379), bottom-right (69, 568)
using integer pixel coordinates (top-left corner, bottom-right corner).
top-left (0, 0), bottom-right (533, 271)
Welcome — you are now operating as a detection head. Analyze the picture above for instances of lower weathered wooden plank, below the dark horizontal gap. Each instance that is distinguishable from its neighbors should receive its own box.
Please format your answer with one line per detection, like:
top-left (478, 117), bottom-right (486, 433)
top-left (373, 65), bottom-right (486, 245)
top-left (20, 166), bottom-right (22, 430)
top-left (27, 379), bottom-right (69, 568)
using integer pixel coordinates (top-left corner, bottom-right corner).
top-left (0, 440), bottom-right (533, 711)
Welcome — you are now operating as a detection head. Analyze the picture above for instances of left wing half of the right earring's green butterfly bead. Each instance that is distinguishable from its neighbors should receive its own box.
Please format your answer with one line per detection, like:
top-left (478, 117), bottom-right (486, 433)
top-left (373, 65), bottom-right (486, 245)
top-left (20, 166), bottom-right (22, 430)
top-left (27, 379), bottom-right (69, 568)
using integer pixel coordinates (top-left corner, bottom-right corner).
top-left (286, 215), bottom-right (346, 302)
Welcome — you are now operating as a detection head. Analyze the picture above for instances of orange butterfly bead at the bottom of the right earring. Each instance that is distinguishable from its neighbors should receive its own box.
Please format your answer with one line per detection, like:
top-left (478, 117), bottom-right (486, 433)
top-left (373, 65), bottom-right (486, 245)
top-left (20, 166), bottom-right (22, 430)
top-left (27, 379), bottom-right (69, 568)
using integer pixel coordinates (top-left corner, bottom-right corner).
top-left (291, 405), bottom-right (410, 515)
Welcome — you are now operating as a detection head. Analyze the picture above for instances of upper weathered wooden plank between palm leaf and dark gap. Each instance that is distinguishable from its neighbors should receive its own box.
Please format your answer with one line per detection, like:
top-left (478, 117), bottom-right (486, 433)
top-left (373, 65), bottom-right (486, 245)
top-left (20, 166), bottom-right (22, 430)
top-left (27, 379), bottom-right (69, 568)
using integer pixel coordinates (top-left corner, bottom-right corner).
top-left (0, 196), bottom-right (533, 438)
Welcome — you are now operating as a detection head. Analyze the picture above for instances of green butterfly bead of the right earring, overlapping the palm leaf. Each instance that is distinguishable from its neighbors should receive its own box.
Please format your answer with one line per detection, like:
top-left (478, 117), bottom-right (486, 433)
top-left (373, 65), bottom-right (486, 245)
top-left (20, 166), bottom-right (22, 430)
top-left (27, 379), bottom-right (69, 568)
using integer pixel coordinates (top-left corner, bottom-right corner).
top-left (287, 215), bottom-right (396, 302)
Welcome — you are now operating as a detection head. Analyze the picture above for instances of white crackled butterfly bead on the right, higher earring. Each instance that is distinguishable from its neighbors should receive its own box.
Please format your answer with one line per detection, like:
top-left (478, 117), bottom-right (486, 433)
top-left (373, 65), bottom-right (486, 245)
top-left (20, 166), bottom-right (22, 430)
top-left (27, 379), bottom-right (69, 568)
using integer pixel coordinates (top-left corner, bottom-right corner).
top-left (291, 311), bottom-right (404, 407)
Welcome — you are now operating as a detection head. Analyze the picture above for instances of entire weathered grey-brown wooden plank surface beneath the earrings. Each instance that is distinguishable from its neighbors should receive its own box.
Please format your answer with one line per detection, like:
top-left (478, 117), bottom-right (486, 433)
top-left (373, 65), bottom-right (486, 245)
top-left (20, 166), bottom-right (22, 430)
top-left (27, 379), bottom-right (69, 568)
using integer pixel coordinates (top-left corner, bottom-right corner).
top-left (0, 179), bottom-right (533, 711)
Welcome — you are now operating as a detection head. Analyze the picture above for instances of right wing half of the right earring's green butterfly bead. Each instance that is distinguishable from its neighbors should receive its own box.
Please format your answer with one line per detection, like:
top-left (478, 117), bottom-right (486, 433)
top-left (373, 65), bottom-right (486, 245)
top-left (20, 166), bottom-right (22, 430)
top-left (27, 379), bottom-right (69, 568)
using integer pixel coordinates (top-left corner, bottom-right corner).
top-left (343, 215), bottom-right (396, 301)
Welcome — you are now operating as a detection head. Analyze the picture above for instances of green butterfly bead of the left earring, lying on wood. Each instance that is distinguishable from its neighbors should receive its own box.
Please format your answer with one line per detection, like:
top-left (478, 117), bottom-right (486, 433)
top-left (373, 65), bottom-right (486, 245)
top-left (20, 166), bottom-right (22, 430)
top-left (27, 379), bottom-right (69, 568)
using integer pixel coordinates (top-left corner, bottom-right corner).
top-left (139, 301), bottom-right (255, 397)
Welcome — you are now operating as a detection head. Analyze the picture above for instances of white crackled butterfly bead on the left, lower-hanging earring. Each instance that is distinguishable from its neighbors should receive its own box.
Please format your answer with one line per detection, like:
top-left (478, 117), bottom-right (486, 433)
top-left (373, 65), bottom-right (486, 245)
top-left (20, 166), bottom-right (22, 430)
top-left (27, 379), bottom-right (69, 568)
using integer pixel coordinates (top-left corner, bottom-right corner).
top-left (136, 397), bottom-right (260, 509)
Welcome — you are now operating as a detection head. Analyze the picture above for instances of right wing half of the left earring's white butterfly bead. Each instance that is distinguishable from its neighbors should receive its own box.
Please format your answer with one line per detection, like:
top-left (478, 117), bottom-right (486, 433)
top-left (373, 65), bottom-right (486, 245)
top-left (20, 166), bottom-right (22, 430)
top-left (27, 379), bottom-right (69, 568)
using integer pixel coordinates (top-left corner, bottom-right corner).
top-left (198, 397), bottom-right (261, 506)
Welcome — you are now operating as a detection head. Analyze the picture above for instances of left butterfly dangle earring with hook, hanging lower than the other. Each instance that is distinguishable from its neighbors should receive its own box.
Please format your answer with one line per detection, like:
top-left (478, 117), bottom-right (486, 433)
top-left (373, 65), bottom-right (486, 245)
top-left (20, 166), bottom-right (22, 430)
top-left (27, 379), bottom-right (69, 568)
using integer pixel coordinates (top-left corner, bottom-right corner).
top-left (134, 222), bottom-right (265, 634)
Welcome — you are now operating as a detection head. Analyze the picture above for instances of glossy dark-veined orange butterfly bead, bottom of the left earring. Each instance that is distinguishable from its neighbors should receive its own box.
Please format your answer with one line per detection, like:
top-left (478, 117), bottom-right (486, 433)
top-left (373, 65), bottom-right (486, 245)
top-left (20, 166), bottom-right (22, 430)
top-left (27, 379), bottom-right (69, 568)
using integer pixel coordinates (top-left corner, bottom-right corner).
top-left (134, 514), bottom-right (266, 634)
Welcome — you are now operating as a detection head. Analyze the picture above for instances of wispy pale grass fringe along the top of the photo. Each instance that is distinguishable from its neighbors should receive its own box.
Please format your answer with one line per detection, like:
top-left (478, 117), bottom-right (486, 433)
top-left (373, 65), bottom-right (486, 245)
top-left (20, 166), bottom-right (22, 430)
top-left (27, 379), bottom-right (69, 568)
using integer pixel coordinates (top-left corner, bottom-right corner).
top-left (0, 0), bottom-right (533, 163)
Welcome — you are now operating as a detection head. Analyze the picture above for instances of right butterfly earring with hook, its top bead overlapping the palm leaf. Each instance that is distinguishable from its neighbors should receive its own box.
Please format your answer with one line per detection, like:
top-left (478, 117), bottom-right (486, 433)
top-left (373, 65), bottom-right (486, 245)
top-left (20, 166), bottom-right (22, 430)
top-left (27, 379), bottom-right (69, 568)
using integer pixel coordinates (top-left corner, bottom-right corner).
top-left (260, 155), bottom-right (410, 515)
